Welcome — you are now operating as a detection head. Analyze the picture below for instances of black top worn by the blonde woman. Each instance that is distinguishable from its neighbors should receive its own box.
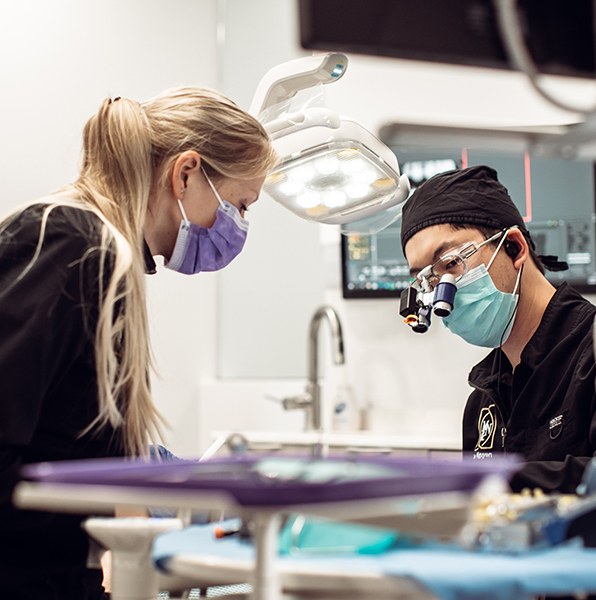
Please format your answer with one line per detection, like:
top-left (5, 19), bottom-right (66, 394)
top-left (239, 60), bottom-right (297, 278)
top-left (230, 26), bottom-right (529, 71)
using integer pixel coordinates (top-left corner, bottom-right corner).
top-left (0, 203), bottom-right (132, 598)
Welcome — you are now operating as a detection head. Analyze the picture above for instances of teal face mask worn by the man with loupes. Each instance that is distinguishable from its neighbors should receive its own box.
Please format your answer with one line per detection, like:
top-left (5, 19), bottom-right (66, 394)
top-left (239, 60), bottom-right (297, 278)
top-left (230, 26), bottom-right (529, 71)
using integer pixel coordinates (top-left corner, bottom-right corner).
top-left (443, 255), bottom-right (521, 348)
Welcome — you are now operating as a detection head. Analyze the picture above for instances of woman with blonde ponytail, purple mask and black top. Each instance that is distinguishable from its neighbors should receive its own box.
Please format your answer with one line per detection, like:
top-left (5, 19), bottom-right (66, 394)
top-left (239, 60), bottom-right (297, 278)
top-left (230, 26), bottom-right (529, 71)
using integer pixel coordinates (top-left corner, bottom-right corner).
top-left (0, 88), bottom-right (275, 600)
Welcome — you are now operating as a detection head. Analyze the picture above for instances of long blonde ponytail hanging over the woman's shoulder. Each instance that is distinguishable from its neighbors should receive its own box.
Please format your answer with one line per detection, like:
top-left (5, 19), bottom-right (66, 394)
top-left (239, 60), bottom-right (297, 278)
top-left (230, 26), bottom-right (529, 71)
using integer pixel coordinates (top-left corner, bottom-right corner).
top-left (75, 99), bottom-right (162, 455)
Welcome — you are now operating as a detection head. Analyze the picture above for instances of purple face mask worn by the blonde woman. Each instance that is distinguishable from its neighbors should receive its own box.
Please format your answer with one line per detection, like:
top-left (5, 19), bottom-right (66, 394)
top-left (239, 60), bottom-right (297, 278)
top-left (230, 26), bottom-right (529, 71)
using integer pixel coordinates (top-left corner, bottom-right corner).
top-left (166, 171), bottom-right (248, 275)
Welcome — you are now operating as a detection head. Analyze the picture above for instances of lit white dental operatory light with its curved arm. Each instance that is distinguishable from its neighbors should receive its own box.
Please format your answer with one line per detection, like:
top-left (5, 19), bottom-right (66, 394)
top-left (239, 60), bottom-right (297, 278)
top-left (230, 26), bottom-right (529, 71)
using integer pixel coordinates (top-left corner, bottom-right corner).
top-left (251, 53), bottom-right (410, 233)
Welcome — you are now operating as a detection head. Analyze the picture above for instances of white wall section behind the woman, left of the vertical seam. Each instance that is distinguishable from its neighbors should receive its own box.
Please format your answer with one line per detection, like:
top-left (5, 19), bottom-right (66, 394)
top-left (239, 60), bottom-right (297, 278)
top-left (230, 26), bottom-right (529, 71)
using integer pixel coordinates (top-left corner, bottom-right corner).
top-left (0, 0), bottom-right (218, 450)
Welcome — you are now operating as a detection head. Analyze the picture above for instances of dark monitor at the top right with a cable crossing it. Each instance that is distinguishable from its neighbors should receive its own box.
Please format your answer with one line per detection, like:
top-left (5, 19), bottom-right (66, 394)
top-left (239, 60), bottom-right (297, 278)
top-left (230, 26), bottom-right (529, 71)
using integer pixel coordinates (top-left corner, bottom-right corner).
top-left (299, 0), bottom-right (594, 78)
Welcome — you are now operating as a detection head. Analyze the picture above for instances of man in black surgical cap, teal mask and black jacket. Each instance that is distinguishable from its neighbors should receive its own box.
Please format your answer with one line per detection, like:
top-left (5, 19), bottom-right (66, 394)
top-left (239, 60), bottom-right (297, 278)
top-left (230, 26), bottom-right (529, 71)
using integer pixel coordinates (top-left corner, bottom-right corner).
top-left (401, 166), bottom-right (596, 493)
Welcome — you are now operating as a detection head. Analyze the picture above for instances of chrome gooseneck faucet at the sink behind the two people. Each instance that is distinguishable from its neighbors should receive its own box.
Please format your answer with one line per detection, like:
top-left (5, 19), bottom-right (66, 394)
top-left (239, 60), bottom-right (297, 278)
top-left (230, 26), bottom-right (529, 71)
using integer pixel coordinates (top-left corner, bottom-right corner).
top-left (282, 306), bottom-right (345, 431)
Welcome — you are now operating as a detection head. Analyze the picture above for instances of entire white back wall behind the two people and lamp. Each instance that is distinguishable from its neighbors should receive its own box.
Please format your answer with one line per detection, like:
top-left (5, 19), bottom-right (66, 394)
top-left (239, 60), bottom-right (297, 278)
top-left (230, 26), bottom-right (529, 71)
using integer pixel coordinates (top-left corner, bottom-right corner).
top-left (0, 0), bottom-right (592, 455)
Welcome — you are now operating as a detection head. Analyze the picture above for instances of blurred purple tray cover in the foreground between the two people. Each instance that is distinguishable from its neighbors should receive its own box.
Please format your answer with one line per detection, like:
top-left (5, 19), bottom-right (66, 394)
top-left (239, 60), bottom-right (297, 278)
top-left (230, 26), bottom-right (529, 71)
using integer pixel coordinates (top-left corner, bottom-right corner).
top-left (22, 454), bottom-right (517, 506)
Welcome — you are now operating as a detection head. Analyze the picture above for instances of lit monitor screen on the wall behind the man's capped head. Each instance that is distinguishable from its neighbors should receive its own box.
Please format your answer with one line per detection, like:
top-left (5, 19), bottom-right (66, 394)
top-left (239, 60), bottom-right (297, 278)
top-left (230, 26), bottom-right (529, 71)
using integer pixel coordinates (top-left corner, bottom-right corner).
top-left (341, 146), bottom-right (596, 298)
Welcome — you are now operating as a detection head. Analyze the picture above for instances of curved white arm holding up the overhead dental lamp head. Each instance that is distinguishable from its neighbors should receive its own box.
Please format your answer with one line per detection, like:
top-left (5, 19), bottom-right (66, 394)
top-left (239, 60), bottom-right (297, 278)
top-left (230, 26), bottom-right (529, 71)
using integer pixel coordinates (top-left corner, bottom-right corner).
top-left (250, 52), bottom-right (348, 116)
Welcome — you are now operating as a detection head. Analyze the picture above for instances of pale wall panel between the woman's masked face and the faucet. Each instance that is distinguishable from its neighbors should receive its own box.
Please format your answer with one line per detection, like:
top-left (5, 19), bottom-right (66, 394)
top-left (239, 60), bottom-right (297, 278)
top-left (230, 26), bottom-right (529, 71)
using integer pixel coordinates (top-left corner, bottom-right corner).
top-left (216, 0), bottom-right (323, 379)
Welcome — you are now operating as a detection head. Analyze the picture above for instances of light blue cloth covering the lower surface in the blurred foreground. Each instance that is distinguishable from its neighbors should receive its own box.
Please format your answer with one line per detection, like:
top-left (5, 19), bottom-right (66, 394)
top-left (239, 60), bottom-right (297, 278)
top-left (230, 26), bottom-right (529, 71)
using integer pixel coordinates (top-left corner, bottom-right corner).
top-left (153, 521), bottom-right (596, 600)
